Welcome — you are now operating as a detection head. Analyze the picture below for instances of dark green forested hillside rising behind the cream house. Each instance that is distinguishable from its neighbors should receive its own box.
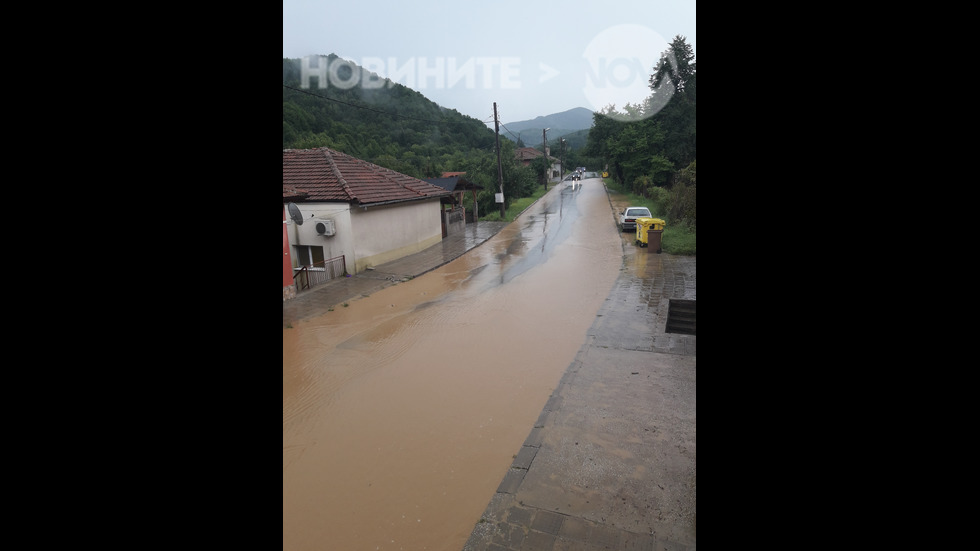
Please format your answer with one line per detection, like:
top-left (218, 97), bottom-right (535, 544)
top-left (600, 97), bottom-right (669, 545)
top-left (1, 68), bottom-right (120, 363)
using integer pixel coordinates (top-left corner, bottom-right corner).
top-left (282, 54), bottom-right (542, 217)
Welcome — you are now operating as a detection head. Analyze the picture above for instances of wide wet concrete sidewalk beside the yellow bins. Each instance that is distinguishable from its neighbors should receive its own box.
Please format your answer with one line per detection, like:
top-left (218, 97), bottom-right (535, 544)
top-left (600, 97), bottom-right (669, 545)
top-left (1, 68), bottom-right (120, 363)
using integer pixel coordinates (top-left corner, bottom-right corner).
top-left (464, 251), bottom-right (697, 551)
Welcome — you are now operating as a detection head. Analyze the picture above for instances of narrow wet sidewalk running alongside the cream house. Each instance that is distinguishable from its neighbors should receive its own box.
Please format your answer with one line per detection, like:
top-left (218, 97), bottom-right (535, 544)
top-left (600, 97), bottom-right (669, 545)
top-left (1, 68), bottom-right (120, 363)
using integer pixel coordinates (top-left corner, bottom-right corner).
top-left (282, 221), bottom-right (508, 327)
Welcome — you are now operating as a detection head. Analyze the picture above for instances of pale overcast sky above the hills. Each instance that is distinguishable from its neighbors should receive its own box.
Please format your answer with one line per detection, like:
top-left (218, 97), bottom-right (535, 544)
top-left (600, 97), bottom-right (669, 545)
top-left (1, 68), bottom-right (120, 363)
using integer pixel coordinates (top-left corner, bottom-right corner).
top-left (282, 0), bottom-right (697, 127)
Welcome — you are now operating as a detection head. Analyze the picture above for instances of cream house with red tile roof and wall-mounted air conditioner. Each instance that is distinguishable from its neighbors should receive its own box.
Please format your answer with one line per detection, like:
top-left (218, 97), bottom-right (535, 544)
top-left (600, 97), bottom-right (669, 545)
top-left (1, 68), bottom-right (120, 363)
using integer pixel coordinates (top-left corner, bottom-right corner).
top-left (282, 147), bottom-right (451, 300)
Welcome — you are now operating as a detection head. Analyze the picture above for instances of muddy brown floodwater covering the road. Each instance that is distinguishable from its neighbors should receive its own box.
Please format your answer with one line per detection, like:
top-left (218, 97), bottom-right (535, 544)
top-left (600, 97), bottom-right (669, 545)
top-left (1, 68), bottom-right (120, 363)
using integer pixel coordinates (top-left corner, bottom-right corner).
top-left (282, 179), bottom-right (623, 551)
